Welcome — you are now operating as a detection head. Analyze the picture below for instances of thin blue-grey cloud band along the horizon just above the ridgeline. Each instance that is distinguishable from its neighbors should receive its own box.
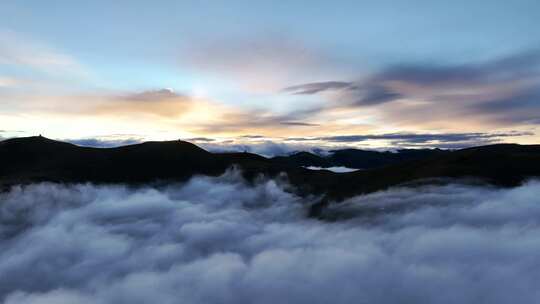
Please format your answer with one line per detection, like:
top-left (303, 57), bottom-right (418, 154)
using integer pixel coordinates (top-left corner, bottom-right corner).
top-left (61, 131), bottom-right (534, 157)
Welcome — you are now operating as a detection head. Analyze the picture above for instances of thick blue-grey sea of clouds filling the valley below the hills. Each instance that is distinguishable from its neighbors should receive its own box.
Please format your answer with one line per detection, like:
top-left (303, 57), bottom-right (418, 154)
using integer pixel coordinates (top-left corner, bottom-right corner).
top-left (0, 172), bottom-right (540, 304)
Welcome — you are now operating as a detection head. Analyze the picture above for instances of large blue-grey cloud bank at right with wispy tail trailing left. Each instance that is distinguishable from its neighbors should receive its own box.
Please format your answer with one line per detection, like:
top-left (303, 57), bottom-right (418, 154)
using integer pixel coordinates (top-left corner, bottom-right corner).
top-left (284, 49), bottom-right (540, 129)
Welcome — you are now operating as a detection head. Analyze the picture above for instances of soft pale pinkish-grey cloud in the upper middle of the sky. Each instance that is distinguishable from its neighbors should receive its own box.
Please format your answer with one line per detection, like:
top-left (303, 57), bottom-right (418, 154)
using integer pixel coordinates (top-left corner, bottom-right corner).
top-left (181, 33), bottom-right (342, 93)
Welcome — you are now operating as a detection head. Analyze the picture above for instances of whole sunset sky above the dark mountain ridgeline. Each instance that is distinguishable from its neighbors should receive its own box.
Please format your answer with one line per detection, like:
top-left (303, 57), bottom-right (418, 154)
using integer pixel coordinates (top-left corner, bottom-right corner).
top-left (0, 0), bottom-right (540, 149)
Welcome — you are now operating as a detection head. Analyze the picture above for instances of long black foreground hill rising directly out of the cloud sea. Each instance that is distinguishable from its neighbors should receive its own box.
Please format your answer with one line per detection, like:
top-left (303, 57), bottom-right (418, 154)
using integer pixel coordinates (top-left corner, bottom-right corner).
top-left (0, 137), bottom-right (540, 215)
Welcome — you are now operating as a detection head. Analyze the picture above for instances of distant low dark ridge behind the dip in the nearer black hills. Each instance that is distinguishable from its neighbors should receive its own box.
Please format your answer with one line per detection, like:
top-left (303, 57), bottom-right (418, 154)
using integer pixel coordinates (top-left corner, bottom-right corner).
top-left (272, 149), bottom-right (450, 169)
